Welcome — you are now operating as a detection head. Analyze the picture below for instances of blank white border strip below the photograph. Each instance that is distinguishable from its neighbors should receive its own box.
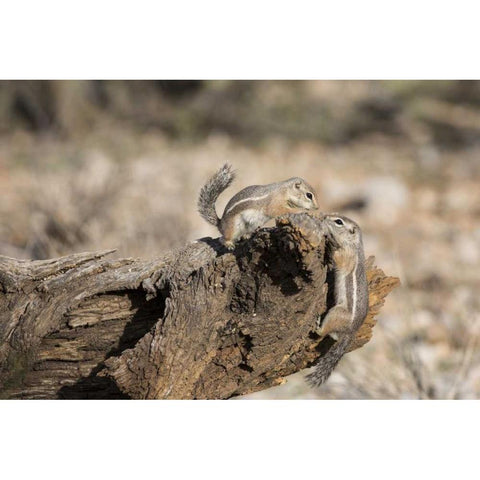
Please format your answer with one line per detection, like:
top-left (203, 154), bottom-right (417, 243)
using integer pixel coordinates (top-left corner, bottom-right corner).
top-left (0, 400), bottom-right (480, 480)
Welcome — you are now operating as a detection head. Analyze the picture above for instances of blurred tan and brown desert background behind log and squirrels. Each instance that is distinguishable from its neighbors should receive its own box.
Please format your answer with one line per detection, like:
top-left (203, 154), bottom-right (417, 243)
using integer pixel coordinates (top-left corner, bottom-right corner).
top-left (0, 80), bottom-right (480, 398)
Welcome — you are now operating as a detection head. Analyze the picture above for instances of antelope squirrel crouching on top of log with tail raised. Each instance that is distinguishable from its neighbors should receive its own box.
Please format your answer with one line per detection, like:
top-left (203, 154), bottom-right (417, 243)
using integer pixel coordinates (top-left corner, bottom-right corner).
top-left (198, 164), bottom-right (318, 250)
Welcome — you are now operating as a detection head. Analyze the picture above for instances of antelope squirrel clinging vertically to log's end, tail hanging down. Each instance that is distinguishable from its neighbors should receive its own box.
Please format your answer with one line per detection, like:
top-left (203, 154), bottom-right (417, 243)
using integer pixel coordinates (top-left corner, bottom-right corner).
top-left (307, 214), bottom-right (368, 387)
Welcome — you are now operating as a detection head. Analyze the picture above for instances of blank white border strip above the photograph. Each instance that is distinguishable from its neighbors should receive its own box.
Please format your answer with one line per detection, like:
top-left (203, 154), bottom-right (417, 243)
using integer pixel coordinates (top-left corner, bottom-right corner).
top-left (0, 0), bottom-right (480, 79)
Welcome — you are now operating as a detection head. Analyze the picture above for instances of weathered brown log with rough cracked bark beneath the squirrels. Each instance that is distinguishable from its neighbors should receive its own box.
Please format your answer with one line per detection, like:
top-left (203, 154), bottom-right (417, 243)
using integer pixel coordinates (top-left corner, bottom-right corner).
top-left (0, 214), bottom-right (398, 399)
